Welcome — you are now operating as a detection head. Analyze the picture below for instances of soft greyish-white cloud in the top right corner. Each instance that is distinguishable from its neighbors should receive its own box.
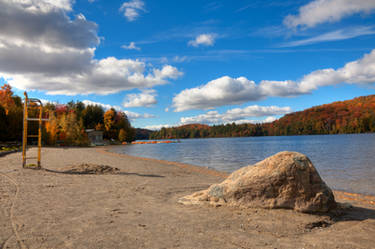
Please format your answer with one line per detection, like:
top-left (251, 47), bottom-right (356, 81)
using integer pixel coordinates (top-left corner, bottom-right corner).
top-left (284, 0), bottom-right (375, 28)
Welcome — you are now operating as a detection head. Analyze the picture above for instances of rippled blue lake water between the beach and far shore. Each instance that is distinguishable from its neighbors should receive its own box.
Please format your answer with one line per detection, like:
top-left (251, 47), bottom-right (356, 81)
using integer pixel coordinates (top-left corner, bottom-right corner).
top-left (112, 134), bottom-right (375, 195)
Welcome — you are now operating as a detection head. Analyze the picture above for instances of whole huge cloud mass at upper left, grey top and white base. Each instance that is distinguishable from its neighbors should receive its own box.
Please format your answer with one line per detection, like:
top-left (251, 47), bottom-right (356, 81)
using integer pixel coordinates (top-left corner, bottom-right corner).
top-left (0, 0), bottom-right (182, 95)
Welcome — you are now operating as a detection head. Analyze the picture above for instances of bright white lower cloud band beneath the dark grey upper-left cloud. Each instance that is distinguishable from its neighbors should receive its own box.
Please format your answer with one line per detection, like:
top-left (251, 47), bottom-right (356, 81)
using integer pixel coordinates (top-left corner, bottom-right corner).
top-left (4, 57), bottom-right (181, 95)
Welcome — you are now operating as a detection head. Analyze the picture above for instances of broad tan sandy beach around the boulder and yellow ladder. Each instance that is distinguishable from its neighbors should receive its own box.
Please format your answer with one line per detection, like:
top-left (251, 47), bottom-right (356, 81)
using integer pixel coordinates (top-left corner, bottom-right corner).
top-left (0, 148), bottom-right (375, 249)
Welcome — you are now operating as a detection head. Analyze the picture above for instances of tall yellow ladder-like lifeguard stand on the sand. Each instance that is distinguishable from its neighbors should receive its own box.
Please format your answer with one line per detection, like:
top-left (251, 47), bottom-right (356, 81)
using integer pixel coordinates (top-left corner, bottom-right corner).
top-left (22, 92), bottom-right (48, 169)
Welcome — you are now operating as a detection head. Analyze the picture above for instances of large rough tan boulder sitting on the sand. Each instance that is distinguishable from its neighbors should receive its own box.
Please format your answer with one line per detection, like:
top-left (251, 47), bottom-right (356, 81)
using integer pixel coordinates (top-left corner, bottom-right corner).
top-left (179, 151), bottom-right (336, 213)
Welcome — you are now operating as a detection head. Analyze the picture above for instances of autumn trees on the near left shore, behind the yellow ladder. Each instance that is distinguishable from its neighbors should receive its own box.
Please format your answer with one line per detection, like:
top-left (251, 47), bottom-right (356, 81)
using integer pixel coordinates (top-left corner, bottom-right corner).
top-left (0, 84), bottom-right (135, 146)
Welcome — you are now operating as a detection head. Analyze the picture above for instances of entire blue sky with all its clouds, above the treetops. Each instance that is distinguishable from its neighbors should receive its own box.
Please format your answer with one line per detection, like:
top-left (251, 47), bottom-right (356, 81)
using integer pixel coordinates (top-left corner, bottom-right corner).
top-left (0, 0), bottom-right (375, 128)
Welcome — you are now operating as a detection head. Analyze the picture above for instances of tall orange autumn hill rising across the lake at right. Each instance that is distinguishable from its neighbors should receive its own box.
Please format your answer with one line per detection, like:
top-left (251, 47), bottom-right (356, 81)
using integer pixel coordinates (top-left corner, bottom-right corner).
top-left (264, 95), bottom-right (375, 135)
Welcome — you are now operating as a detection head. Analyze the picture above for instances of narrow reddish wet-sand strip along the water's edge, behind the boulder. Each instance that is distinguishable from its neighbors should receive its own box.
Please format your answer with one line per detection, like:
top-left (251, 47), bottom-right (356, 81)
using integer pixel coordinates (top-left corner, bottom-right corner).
top-left (103, 145), bottom-right (375, 208)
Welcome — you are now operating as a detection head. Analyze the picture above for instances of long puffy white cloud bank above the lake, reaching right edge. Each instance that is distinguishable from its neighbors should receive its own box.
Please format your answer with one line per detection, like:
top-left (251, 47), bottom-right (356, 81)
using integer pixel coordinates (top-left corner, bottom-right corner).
top-left (173, 50), bottom-right (375, 112)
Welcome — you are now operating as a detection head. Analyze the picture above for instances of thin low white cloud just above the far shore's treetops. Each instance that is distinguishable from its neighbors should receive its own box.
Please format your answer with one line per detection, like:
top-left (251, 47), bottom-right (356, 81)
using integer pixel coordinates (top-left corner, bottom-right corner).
top-left (180, 105), bottom-right (292, 124)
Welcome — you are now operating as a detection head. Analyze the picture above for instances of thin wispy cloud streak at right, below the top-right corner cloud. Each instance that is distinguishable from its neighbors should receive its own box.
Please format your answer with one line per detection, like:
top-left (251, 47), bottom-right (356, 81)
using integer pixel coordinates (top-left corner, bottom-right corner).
top-left (281, 26), bottom-right (375, 47)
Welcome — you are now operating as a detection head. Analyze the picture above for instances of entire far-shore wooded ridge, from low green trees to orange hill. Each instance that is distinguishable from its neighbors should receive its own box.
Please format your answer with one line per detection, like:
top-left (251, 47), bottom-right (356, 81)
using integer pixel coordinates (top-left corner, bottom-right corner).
top-left (150, 95), bottom-right (375, 139)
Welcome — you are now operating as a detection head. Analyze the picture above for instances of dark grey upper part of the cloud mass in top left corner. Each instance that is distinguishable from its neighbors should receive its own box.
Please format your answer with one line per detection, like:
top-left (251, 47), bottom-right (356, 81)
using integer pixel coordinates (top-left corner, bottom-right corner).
top-left (0, 0), bottom-right (100, 49)
